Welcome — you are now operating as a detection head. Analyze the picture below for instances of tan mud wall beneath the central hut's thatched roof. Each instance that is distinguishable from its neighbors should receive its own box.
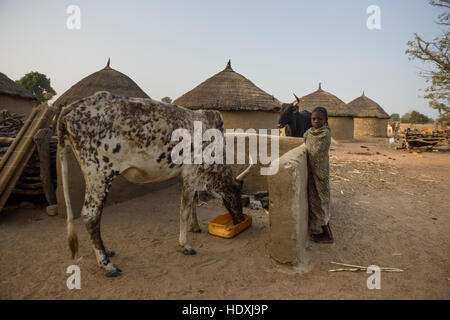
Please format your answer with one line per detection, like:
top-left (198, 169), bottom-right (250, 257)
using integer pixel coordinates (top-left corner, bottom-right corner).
top-left (220, 111), bottom-right (280, 134)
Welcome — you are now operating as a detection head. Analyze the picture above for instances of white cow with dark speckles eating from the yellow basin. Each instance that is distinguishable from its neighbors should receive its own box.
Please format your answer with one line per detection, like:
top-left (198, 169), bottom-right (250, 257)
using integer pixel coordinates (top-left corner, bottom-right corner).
top-left (58, 92), bottom-right (250, 277)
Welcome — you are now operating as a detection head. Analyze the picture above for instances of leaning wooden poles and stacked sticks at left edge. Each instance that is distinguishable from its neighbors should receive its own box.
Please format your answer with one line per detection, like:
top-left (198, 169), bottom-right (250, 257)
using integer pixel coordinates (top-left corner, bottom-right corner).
top-left (0, 105), bottom-right (57, 211)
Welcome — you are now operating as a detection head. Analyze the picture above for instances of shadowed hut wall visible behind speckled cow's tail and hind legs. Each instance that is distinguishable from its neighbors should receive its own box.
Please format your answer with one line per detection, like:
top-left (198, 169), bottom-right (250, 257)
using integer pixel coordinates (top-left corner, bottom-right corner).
top-left (56, 147), bottom-right (179, 218)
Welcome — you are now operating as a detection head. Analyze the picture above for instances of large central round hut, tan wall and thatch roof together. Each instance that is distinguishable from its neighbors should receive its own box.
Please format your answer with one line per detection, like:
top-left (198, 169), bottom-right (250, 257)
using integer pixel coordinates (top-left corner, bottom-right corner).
top-left (173, 61), bottom-right (281, 134)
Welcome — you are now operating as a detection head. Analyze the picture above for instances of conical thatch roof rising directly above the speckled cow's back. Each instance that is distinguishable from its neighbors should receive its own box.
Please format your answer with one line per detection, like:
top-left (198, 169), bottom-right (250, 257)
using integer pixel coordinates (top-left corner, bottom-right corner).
top-left (53, 59), bottom-right (149, 107)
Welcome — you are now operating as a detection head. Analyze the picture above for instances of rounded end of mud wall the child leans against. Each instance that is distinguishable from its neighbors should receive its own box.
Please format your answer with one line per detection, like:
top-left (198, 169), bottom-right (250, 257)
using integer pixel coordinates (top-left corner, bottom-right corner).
top-left (268, 145), bottom-right (308, 266)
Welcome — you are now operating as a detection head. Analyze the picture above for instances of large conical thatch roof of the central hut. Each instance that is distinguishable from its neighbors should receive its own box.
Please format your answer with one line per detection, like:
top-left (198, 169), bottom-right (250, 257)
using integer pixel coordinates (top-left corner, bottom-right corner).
top-left (173, 61), bottom-right (281, 112)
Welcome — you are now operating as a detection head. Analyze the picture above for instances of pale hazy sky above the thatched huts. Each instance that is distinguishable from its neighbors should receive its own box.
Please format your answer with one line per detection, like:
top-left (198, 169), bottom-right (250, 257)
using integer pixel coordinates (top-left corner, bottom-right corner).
top-left (0, 0), bottom-right (440, 117)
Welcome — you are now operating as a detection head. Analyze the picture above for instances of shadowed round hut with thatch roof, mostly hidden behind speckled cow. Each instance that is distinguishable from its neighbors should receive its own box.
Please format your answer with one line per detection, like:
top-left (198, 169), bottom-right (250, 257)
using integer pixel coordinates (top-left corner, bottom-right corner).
top-left (53, 59), bottom-right (176, 217)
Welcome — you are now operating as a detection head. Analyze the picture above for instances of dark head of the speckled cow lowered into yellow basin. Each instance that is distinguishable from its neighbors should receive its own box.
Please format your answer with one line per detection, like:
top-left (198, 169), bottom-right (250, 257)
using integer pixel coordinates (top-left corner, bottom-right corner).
top-left (218, 159), bottom-right (253, 224)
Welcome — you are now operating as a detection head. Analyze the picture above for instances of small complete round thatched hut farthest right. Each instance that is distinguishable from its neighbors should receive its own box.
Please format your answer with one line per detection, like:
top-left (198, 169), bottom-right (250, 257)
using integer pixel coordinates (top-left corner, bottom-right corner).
top-left (348, 91), bottom-right (390, 138)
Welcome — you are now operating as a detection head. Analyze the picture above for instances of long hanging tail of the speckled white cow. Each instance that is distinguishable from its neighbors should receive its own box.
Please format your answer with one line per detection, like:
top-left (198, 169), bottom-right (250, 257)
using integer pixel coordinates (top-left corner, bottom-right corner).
top-left (58, 111), bottom-right (78, 259)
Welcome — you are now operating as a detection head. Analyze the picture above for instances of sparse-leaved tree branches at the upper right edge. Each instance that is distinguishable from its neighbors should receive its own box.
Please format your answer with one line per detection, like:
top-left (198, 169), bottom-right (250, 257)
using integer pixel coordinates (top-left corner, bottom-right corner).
top-left (406, 0), bottom-right (450, 118)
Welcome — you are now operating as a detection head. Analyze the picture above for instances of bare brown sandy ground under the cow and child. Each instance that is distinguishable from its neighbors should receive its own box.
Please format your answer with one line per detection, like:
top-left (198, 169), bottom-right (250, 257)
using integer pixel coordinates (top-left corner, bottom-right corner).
top-left (0, 140), bottom-right (450, 299)
